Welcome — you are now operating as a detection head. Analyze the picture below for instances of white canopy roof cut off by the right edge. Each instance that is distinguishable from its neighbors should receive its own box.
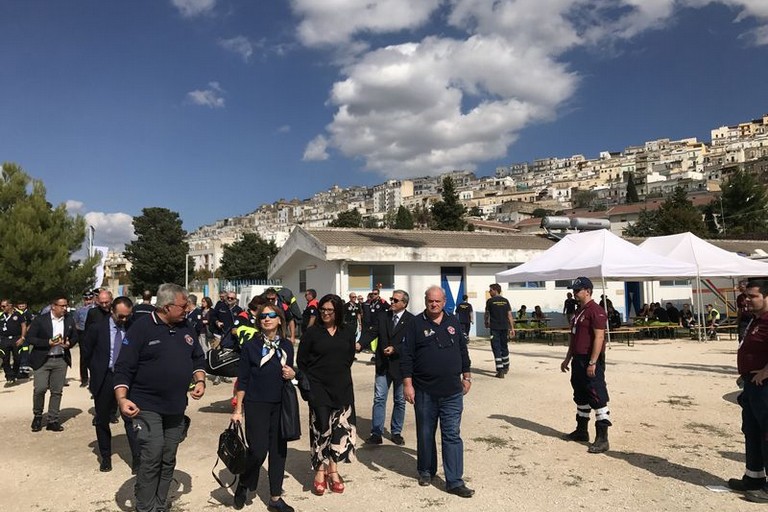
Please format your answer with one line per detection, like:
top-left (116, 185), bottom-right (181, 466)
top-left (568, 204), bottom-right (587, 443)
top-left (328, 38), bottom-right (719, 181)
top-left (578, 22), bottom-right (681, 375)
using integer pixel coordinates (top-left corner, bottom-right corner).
top-left (640, 233), bottom-right (768, 277)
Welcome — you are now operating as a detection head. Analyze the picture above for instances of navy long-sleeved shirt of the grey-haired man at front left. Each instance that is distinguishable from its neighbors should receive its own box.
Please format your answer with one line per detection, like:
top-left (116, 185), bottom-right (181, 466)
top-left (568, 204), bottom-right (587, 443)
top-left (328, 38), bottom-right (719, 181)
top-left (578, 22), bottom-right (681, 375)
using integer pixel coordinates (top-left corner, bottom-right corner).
top-left (114, 313), bottom-right (205, 414)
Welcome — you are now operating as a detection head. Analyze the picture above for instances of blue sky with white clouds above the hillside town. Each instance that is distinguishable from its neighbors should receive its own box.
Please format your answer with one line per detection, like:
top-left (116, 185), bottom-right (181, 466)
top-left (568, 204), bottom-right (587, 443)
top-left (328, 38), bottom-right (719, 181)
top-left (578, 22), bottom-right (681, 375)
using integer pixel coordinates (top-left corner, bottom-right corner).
top-left (0, 0), bottom-right (768, 248)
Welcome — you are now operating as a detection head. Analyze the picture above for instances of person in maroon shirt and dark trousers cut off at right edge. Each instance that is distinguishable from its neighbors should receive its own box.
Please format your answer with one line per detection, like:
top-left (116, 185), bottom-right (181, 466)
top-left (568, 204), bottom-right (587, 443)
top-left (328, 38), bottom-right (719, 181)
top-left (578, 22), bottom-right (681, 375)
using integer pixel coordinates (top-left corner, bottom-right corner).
top-left (728, 278), bottom-right (768, 503)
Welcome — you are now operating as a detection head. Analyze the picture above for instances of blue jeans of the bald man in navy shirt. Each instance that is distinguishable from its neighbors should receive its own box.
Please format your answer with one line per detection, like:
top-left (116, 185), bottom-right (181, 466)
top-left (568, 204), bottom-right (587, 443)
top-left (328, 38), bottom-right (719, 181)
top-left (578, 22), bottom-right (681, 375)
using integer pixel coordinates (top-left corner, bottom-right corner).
top-left (414, 389), bottom-right (464, 489)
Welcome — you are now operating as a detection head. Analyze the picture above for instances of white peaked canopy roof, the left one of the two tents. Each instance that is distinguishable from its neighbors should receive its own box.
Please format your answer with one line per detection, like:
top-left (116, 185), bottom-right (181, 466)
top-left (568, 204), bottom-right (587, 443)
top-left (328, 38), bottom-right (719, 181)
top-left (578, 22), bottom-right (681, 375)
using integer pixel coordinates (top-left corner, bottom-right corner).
top-left (496, 229), bottom-right (696, 283)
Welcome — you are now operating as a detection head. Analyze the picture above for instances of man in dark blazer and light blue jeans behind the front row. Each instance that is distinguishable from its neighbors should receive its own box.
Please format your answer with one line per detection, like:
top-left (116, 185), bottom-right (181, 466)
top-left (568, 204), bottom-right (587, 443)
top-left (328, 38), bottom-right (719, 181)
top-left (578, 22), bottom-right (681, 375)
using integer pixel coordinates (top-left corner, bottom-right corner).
top-left (365, 290), bottom-right (413, 445)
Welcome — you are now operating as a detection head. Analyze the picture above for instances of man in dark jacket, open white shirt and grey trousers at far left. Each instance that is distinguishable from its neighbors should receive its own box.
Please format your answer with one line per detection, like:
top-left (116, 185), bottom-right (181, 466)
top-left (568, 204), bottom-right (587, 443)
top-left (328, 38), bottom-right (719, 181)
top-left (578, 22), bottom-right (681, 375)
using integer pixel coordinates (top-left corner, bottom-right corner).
top-left (27, 295), bottom-right (77, 432)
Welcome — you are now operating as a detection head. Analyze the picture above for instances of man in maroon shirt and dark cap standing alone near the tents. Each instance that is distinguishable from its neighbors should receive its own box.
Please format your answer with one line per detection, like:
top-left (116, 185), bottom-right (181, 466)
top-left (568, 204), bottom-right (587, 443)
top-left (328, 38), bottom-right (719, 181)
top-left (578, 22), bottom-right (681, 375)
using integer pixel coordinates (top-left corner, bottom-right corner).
top-left (560, 277), bottom-right (611, 453)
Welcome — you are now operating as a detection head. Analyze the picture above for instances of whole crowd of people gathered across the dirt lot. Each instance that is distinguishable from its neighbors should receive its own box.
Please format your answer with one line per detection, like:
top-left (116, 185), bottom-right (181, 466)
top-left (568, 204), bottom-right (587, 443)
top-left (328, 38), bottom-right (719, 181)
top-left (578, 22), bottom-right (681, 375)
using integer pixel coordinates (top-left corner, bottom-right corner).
top-left (0, 277), bottom-right (768, 506)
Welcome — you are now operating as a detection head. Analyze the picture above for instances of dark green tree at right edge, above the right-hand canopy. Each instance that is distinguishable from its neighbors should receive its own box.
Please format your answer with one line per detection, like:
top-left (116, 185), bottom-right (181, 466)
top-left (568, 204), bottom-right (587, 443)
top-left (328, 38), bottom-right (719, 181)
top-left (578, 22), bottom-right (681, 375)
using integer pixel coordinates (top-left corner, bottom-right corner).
top-left (713, 171), bottom-right (768, 236)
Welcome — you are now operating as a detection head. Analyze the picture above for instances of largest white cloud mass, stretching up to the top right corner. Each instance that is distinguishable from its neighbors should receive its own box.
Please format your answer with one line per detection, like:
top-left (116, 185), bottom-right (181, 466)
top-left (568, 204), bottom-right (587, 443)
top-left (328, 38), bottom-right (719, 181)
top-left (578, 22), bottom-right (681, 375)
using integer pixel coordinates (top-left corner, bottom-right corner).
top-left (291, 0), bottom-right (768, 177)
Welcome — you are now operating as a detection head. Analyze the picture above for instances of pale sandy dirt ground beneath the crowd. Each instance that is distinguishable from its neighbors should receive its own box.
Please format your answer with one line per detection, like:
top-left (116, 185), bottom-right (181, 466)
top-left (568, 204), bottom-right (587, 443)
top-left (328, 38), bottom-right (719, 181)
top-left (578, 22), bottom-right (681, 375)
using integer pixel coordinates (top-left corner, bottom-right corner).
top-left (0, 339), bottom-right (759, 512)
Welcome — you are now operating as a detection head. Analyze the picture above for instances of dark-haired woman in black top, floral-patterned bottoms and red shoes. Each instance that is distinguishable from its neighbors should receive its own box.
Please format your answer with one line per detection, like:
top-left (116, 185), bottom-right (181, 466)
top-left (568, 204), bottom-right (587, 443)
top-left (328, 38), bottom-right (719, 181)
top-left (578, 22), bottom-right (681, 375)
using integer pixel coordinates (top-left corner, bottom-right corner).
top-left (297, 294), bottom-right (356, 496)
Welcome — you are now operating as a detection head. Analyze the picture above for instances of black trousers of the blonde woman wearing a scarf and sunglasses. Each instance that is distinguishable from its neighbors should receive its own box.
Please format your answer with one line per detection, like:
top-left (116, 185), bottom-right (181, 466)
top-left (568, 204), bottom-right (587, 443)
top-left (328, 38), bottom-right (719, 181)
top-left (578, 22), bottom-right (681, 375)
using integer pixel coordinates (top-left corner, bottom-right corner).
top-left (240, 401), bottom-right (288, 496)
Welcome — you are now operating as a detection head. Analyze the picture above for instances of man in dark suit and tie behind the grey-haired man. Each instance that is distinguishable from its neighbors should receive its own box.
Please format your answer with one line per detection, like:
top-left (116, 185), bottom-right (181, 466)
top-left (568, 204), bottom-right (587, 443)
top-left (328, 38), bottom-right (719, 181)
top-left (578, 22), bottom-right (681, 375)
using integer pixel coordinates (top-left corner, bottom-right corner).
top-left (80, 297), bottom-right (139, 474)
